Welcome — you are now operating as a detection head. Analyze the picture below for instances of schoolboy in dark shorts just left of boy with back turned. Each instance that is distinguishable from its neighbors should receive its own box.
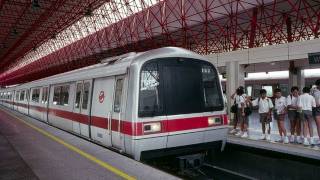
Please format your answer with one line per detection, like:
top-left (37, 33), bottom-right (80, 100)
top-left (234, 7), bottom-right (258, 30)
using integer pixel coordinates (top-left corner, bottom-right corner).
top-left (287, 86), bottom-right (302, 144)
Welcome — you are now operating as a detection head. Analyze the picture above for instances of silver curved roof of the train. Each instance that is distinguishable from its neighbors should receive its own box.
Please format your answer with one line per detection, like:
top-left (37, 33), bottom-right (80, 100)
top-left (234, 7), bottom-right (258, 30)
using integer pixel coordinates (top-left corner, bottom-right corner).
top-left (0, 47), bottom-right (206, 91)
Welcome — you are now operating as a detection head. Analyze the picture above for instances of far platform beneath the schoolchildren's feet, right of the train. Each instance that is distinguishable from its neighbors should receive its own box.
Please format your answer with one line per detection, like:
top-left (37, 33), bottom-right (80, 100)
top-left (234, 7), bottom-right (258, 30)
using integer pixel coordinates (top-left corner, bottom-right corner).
top-left (227, 112), bottom-right (320, 160)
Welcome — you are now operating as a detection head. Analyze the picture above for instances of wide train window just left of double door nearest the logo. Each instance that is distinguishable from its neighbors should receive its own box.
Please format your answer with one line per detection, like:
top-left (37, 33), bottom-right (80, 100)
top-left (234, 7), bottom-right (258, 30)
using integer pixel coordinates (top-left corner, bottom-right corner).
top-left (53, 85), bottom-right (70, 106)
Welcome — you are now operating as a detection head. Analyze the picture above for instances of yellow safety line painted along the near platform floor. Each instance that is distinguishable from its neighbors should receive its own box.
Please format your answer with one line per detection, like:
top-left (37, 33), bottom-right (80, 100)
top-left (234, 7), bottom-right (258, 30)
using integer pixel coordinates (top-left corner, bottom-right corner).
top-left (2, 109), bottom-right (136, 180)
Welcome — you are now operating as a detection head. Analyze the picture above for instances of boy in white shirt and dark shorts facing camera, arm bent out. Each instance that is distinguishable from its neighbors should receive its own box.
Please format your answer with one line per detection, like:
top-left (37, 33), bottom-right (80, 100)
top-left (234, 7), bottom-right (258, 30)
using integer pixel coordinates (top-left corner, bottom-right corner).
top-left (252, 89), bottom-right (273, 141)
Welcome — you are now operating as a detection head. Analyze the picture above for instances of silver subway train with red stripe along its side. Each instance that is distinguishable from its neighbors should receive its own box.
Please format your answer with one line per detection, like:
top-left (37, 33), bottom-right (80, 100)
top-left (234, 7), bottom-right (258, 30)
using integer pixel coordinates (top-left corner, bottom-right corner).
top-left (0, 47), bottom-right (228, 161)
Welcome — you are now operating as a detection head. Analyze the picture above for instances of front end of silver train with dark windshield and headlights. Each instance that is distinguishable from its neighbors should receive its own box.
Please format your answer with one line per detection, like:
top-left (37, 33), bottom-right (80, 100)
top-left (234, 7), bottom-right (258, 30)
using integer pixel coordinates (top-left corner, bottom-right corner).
top-left (133, 58), bottom-right (227, 160)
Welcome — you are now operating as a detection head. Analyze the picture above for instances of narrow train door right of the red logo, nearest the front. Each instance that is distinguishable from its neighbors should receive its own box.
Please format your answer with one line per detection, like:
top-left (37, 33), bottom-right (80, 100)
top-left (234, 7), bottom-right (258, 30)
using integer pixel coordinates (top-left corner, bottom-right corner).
top-left (111, 76), bottom-right (126, 150)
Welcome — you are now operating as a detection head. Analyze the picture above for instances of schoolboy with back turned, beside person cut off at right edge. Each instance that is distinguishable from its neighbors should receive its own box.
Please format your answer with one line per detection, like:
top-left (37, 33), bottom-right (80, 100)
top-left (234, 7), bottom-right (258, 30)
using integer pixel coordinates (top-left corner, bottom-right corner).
top-left (298, 87), bottom-right (316, 146)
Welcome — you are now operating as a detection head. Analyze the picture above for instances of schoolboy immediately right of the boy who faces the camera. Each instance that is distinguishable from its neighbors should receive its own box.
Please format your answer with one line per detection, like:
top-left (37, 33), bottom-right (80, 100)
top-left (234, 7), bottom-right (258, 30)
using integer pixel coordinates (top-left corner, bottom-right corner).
top-left (273, 88), bottom-right (289, 144)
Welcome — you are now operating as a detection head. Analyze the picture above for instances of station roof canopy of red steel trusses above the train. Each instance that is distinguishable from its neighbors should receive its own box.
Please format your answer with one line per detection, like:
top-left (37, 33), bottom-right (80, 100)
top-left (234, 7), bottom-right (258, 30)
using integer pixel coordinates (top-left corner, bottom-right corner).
top-left (0, 0), bottom-right (320, 86)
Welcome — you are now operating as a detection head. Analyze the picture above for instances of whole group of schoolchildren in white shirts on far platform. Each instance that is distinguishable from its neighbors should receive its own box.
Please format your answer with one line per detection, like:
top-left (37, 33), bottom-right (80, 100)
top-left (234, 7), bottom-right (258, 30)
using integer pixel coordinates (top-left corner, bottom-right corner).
top-left (230, 79), bottom-right (320, 146)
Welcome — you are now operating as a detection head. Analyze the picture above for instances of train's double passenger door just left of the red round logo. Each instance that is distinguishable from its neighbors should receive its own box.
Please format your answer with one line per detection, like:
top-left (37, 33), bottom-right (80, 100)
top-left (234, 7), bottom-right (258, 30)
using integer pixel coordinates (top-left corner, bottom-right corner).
top-left (72, 81), bottom-right (91, 137)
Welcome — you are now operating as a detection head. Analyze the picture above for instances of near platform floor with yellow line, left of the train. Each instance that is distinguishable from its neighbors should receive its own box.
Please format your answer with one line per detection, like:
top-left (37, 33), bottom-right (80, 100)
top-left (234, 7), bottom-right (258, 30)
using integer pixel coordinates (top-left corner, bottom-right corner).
top-left (0, 106), bottom-right (178, 180)
